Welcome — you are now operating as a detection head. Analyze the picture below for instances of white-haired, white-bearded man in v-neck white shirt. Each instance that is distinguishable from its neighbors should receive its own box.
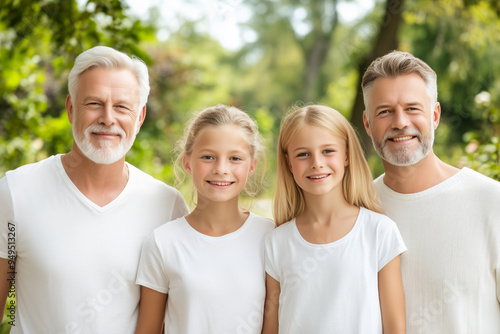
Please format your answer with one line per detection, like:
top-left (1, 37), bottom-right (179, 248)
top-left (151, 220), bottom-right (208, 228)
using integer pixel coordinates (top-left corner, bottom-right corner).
top-left (0, 46), bottom-right (188, 334)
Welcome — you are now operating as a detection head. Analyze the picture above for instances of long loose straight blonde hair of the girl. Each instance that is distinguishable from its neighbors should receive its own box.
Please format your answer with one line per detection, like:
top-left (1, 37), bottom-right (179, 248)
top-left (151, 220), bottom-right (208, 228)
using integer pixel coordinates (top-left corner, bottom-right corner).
top-left (274, 105), bottom-right (381, 225)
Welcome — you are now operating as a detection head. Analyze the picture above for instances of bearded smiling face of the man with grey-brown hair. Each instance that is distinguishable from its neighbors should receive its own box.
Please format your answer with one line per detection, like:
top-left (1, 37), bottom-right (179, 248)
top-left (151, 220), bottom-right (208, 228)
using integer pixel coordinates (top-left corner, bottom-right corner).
top-left (363, 74), bottom-right (440, 166)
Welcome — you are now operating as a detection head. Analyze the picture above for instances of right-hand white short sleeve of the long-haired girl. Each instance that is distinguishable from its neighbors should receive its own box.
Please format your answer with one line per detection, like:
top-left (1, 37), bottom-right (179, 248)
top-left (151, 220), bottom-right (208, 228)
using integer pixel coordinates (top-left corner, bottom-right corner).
top-left (377, 217), bottom-right (406, 271)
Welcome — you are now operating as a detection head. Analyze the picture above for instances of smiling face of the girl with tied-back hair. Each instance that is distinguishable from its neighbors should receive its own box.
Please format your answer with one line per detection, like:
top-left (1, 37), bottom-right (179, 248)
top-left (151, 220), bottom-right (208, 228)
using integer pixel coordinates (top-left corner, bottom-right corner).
top-left (183, 125), bottom-right (257, 202)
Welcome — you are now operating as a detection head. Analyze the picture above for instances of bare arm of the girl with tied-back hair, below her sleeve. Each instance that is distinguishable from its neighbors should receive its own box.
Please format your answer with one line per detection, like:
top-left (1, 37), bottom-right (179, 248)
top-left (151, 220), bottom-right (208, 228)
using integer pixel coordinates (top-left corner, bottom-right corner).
top-left (135, 286), bottom-right (167, 334)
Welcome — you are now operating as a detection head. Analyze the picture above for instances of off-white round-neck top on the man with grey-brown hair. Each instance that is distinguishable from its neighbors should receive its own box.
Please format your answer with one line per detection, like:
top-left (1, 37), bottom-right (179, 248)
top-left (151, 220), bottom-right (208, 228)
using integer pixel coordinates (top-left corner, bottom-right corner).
top-left (375, 168), bottom-right (500, 334)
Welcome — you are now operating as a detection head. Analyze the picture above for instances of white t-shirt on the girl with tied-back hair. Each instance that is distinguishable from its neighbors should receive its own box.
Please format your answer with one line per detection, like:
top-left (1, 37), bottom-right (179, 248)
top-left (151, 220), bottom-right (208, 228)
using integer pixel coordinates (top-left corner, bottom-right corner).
top-left (136, 214), bottom-right (275, 334)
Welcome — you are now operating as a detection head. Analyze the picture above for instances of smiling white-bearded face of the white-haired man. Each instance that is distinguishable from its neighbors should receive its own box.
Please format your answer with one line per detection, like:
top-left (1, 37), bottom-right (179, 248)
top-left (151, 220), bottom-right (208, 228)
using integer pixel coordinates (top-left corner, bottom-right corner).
top-left (66, 68), bottom-right (146, 164)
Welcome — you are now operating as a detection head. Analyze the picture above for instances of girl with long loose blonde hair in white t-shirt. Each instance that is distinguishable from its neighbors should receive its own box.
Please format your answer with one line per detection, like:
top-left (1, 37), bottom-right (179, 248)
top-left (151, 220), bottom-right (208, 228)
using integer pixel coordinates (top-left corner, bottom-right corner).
top-left (263, 105), bottom-right (406, 334)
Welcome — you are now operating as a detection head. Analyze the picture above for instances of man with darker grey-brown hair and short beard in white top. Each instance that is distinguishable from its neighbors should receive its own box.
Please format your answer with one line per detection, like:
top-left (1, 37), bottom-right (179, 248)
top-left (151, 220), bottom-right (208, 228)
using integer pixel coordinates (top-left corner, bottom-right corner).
top-left (362, 51), bottom-right (500, 334)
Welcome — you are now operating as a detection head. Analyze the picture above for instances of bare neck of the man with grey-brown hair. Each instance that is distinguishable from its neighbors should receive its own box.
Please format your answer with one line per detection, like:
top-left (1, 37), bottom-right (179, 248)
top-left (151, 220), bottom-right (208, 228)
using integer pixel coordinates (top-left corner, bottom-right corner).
top-left (383, 151), bottom-right (459, 194)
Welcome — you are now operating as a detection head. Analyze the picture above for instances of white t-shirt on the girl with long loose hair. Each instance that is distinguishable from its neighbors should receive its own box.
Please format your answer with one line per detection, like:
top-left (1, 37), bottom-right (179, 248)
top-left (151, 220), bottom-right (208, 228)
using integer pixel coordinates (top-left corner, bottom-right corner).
top-left (266, 208), bottom-right (406, 334)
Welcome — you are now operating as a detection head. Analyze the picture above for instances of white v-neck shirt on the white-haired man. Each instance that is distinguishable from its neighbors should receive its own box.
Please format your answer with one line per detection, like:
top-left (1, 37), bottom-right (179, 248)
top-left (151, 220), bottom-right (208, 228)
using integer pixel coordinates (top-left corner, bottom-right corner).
top-left (0, 155), bottom-right (188, 334)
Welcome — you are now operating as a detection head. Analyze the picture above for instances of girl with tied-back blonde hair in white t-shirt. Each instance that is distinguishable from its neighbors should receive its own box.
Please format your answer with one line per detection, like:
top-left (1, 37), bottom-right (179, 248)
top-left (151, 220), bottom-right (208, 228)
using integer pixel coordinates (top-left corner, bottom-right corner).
top-left (136, 105), bottom-right (274, 334)
